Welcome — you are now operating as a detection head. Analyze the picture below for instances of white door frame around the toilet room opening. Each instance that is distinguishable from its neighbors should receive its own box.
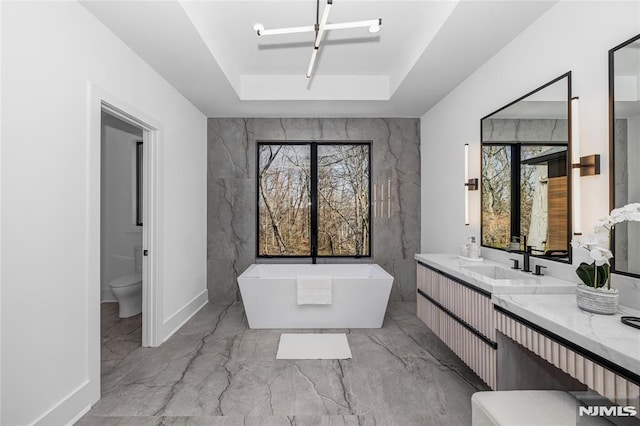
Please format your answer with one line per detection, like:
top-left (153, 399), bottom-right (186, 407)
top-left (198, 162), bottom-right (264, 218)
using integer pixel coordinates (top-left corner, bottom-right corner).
top-left (87, 83), bottom-right (163, 398)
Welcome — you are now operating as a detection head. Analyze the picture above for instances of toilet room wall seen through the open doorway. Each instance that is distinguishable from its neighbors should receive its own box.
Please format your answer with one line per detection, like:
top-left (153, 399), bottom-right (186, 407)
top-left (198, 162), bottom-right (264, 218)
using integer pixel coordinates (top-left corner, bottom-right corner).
top-left (100, 114), bottom-right (142, 302)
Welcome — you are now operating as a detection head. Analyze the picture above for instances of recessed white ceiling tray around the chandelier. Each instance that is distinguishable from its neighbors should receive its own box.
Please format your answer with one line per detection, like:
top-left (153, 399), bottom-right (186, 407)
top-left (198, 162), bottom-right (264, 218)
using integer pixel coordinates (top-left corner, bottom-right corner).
top-left (181, 0), bottom-right (458, 101)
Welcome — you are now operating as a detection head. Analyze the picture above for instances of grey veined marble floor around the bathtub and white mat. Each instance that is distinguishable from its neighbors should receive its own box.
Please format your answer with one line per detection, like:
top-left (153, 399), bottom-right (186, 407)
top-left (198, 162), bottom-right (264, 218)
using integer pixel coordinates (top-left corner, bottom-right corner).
top-left (77, 303), bottom-right (487, 426)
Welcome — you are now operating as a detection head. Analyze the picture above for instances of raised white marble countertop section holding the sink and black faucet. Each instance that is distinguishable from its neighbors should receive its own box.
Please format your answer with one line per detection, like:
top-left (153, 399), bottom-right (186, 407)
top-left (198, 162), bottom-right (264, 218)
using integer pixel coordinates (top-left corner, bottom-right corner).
top-left (415, 253), bottom-right (576, 294)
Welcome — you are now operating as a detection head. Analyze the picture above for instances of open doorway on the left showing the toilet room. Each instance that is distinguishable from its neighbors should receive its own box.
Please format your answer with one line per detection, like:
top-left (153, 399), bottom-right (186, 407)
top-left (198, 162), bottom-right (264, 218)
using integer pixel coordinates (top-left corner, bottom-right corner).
top-left (100, 111), bottom-right (144, 377)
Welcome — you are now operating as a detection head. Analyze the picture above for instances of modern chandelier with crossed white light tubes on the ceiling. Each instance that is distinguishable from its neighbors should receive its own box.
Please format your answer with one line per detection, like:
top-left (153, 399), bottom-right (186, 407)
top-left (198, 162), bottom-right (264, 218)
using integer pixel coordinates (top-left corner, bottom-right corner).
top-left (253, 0), bottom-right (382, 78)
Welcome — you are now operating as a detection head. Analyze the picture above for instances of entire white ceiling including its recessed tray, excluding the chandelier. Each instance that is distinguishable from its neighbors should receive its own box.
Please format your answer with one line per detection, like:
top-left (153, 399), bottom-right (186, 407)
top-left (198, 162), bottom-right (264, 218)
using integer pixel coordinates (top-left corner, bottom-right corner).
top-left (81, 0), bottom-right (556, 117)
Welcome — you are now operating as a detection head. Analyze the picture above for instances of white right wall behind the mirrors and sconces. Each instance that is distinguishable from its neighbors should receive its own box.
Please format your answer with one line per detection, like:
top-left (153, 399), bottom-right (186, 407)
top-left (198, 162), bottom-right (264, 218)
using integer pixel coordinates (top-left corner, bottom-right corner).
top-left (421, 1), bottom-right (640, 290)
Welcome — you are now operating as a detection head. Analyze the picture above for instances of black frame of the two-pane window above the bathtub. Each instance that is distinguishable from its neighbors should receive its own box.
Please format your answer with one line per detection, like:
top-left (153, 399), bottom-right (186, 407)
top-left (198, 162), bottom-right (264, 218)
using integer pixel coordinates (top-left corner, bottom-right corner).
top-left (255, 140), bottom-right (373, 263)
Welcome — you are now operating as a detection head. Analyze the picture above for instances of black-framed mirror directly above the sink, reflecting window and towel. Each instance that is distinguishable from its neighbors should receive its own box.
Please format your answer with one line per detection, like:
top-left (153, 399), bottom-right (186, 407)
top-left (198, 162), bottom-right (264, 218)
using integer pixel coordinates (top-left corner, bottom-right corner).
top-left (480, 72), bottom-right (571, 263)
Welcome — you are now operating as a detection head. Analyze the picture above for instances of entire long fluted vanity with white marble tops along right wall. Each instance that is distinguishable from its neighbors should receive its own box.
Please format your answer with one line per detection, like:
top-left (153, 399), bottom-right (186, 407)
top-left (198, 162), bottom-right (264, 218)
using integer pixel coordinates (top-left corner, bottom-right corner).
top-left (415, 254), bottom-right (640, 417)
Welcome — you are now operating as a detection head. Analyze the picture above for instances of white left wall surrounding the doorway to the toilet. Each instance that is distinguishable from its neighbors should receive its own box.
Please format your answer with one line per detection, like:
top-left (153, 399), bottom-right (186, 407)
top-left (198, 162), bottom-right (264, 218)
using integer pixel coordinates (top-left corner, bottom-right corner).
top-left (0, 2), bottom-right (207, 425)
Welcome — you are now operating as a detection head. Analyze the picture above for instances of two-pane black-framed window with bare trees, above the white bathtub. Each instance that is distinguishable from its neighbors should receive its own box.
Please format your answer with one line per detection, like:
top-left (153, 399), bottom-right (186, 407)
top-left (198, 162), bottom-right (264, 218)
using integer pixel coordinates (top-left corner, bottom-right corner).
top-left (257, 142), bottom-right (371, 258)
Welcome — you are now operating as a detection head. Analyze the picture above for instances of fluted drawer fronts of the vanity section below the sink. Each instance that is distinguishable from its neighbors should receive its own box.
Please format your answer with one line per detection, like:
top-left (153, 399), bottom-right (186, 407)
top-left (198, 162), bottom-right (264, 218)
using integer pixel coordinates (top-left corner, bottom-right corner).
top-left (417, 262), bottom-right (497, 389)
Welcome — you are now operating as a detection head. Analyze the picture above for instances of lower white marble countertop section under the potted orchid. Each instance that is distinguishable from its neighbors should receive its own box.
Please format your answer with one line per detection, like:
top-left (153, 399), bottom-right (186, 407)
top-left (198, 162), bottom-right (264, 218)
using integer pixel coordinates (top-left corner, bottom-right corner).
top-left (492, 294), bottom-right (640, 375)
